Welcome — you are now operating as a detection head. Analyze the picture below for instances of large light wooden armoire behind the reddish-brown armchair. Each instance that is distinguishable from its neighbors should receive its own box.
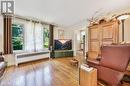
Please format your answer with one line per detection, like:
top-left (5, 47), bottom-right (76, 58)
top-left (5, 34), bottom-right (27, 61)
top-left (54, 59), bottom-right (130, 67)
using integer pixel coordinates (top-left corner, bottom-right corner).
top-left (88, 20), bottom-right (119, 59)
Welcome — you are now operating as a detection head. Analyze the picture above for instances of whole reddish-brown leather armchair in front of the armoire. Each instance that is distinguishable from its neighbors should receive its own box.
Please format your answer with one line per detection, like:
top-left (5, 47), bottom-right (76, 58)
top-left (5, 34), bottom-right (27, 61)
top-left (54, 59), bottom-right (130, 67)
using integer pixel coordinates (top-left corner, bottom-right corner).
top-left (88, 45), bottom-right (130, 86)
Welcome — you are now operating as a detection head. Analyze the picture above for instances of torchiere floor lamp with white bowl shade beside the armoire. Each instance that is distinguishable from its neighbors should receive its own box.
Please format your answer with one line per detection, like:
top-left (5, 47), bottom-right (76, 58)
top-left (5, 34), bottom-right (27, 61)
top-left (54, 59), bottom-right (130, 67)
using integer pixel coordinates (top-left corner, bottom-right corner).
top-left (117, 13), bottom-right (130, 42)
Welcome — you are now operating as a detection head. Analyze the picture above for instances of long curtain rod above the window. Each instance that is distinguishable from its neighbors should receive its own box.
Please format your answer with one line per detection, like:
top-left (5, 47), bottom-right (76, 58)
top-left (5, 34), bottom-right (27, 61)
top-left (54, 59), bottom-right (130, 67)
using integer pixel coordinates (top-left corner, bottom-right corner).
top-left (14, 15), bottom-right (57, 26)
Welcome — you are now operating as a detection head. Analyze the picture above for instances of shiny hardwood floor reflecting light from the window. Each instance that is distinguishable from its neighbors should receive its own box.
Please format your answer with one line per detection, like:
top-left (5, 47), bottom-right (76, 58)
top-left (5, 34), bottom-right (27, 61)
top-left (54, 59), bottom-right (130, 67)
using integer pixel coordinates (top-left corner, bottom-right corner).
top-left (0, 58), bottom-right (130, 86)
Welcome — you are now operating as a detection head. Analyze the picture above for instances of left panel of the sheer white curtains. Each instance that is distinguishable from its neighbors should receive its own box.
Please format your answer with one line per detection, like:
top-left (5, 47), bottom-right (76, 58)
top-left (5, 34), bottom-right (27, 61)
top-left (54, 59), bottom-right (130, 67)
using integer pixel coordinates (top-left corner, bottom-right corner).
top-left (24, 21), bottom-right (35, 52)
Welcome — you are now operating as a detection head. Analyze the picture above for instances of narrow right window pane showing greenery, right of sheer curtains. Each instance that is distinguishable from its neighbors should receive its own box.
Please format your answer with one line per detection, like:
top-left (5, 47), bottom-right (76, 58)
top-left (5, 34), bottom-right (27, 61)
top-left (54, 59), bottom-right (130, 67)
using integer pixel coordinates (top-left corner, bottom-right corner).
top-left (43, 27), bottom-right (49, 48)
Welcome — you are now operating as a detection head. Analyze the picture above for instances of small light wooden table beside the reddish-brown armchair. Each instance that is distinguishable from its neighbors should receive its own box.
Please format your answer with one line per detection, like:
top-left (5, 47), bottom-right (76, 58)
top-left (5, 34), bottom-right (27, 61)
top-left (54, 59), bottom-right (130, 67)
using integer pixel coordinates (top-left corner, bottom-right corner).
top-left (79, 65), bottom-right (97, 86)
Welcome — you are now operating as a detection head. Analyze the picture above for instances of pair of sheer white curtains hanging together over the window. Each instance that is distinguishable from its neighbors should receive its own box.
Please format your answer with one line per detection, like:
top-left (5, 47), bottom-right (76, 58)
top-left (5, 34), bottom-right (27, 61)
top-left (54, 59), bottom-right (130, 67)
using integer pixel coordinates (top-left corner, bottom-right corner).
top-left (19, 21), bottom-right (48, 52)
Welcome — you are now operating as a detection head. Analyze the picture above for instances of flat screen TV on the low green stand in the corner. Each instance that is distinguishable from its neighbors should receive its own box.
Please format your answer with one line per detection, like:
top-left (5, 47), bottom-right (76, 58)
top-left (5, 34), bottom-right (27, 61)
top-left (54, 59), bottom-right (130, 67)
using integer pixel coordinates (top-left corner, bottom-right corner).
top-left (54, 39), bottom-right (72, 50)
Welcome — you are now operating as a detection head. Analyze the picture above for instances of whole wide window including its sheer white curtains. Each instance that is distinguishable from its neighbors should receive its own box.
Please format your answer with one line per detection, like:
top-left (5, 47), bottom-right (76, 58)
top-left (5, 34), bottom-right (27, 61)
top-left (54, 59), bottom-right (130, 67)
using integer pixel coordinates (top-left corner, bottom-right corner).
top-left (12, 19), bottom-right (49, 52)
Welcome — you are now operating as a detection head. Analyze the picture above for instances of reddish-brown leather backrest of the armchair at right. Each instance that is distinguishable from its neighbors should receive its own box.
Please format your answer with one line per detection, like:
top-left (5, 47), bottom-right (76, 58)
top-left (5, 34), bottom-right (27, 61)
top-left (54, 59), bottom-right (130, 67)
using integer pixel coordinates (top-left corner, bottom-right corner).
top-left (100, 45), bottom-right (130, 72)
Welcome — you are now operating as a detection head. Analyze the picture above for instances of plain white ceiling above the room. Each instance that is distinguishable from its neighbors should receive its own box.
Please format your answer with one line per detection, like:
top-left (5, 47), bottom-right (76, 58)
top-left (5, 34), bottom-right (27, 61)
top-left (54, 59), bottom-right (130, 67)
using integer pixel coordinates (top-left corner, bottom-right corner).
top-left (15, 0), bottom-right (130, 27)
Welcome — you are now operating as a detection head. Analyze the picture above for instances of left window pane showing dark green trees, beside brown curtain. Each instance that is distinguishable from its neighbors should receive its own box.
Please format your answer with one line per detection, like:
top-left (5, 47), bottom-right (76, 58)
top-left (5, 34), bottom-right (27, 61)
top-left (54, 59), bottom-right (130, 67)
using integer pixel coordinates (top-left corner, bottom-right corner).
top-left (12, 24), bottom-right (24, 50)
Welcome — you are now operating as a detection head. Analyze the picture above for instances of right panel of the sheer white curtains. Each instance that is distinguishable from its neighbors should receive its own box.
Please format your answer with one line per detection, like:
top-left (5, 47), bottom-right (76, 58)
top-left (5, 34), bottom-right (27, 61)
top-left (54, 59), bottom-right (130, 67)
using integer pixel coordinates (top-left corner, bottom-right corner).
top-left (34, 23), bottom-right (43, 51)
